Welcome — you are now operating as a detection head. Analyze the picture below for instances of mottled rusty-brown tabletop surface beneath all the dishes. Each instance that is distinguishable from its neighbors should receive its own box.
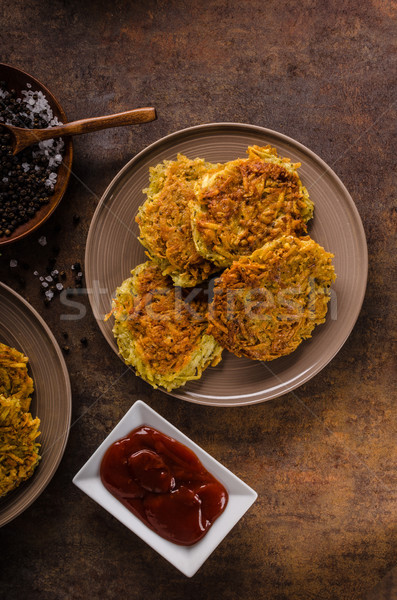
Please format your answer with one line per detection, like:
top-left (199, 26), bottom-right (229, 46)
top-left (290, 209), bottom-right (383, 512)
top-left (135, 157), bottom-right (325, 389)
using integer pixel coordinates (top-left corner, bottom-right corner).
top-left (0, 0), bottom-right (397, 600)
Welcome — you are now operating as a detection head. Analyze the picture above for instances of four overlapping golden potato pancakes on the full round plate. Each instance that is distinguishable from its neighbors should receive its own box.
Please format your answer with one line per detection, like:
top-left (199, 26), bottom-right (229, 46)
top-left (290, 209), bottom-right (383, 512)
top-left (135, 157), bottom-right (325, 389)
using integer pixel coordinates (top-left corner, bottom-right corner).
top-left (108, 146), bottom-right (335, 391)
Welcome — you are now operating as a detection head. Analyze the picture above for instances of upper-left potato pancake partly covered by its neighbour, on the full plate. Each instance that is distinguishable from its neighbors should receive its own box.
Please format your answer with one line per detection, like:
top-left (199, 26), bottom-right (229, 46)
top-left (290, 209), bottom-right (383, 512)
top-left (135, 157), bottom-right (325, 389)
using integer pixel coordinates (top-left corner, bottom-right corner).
top-left (136, 154), bottom-right (217, 287)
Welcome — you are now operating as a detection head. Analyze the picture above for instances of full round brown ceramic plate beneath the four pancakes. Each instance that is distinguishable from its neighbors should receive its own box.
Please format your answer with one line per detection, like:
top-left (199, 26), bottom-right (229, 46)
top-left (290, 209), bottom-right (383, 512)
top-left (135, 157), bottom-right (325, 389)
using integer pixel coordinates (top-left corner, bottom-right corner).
top-left (85, 123), bottom-right (368, 406)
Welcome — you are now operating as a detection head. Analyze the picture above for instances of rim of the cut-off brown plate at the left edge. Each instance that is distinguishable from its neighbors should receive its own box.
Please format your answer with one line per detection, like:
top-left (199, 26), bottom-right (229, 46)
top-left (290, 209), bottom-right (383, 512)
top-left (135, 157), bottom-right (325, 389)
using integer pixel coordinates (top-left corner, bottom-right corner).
top-left (0, 281), bottom-right (72, 528)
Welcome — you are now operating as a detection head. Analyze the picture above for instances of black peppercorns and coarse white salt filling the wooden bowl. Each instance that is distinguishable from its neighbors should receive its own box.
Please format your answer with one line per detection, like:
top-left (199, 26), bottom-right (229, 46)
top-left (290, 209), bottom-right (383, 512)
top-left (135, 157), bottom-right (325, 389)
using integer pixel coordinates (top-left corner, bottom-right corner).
top-left (0, 82), bottom-right (64, 237)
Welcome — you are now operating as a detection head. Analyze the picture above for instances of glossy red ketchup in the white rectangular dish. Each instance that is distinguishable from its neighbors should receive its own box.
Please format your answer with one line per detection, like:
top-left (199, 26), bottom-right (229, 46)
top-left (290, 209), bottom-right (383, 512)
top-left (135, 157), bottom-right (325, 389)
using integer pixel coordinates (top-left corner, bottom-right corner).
top-left (101, 425), bottom-right (228, 546)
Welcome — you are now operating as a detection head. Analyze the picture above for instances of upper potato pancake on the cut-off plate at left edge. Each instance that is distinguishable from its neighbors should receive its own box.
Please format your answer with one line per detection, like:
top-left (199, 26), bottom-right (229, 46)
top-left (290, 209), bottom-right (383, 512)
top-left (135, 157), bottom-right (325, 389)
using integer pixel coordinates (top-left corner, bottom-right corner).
top-left (0, 343), bottom-right (33, 410)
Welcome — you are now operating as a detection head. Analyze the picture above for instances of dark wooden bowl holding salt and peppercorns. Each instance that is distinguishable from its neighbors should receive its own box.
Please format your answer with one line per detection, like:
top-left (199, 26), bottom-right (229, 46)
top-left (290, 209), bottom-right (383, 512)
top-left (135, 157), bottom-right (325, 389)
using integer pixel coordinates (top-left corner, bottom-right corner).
top-left (0, 63), bottom-right (73, 246)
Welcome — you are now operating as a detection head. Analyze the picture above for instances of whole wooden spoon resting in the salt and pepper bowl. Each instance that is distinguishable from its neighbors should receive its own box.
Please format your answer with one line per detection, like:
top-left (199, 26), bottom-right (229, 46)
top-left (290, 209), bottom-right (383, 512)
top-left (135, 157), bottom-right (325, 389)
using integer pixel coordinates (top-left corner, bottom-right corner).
top-left (0, 107), bottom-right (157, 154)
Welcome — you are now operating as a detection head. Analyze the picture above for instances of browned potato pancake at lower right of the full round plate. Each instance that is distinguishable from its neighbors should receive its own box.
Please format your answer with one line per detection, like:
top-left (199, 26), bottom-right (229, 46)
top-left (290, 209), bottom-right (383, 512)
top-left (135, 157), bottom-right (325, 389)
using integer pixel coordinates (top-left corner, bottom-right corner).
top-left (208, 236), bottom-right (335, 361)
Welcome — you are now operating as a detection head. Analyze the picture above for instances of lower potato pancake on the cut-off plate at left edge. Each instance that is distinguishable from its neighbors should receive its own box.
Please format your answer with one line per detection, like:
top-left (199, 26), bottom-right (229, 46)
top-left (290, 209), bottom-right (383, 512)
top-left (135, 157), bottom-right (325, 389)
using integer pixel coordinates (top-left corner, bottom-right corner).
top-left (0, 395), bottom-right (40, 496)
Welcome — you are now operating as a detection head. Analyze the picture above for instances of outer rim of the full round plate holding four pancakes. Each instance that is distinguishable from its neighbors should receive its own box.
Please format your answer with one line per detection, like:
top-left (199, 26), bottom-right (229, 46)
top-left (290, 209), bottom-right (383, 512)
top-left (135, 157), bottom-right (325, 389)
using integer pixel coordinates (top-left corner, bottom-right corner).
top-left (84, 121), bottom-right (368, 407)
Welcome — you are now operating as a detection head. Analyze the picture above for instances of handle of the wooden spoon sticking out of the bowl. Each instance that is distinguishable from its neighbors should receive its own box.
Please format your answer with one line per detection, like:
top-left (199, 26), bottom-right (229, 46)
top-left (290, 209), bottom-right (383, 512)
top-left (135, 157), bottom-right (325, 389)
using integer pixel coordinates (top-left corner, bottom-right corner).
top-left (35, 107), bottom-right (156, 140)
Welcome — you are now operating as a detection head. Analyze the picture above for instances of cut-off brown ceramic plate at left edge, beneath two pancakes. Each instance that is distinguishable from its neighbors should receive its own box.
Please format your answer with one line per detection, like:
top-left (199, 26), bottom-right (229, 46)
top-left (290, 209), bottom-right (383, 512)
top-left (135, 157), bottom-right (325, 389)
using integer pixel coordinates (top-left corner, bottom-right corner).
top-left (0, 283), bottom-right (72, 526)
